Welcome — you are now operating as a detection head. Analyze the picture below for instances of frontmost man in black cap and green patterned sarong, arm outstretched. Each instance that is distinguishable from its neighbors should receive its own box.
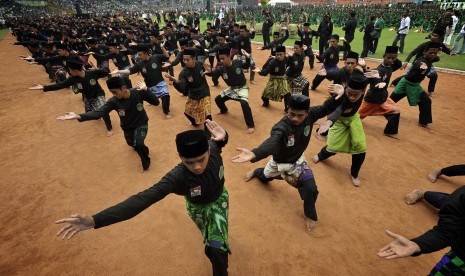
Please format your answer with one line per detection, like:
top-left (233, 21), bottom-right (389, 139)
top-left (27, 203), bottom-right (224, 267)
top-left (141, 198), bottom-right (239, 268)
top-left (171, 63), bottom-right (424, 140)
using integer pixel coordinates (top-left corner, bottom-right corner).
top-left (55, 120), bottom-right (231, 276)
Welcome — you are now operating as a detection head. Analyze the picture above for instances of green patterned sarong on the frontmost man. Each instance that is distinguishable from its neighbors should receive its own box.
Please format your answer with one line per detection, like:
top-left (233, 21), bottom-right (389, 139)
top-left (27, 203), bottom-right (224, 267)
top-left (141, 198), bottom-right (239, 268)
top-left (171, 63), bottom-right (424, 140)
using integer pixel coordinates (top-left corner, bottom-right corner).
top-left (186, 187), bottom-right (230, 252)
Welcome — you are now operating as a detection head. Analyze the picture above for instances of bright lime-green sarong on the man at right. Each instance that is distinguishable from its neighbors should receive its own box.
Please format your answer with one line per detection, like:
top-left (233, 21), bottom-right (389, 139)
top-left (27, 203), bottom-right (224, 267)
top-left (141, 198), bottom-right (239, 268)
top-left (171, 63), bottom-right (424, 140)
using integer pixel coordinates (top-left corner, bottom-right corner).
top-left (326, 112), bottom-right (367, 154)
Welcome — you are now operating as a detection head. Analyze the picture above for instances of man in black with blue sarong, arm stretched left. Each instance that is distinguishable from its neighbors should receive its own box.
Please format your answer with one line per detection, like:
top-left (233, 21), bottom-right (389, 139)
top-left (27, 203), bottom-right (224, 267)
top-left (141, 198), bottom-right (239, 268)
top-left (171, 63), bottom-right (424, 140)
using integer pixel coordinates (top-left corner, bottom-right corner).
top-left (112, 45), bottom-right (173, 119)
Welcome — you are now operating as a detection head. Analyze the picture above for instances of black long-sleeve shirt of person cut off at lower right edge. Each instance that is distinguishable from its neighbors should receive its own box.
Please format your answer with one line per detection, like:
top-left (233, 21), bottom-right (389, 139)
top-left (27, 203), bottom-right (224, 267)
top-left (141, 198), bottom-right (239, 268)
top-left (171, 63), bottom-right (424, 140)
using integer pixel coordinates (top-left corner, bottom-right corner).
top-left (412, 186), bottom-right (465, 260)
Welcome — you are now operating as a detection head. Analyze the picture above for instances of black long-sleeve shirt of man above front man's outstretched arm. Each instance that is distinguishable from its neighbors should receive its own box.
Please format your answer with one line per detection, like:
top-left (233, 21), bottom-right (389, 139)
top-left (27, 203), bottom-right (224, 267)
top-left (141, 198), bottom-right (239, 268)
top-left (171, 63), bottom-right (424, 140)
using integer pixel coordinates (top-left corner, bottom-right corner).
top-left (78, 88), bottom-right (160, 131)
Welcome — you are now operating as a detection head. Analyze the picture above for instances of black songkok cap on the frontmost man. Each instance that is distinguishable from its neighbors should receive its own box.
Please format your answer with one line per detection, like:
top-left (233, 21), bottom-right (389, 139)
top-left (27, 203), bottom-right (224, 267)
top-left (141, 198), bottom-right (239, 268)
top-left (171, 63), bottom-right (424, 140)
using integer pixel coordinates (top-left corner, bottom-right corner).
top-left (176, 130), bottom-right (209, 158)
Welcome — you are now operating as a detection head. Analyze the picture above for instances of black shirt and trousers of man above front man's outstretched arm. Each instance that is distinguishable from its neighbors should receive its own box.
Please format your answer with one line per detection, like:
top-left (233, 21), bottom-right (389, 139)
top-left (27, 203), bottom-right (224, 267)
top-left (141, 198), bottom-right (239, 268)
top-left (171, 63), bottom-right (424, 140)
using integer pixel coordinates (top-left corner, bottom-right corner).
top-left (79, 89), bottom-right (160, 170)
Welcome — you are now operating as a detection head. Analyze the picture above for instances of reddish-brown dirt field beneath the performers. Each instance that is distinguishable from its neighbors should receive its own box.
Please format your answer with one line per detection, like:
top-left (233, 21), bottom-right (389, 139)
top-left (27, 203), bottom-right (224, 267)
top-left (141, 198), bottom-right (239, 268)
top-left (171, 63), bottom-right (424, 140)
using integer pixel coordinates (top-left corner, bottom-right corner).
top-left (0, 35), bottom-right (465, 275)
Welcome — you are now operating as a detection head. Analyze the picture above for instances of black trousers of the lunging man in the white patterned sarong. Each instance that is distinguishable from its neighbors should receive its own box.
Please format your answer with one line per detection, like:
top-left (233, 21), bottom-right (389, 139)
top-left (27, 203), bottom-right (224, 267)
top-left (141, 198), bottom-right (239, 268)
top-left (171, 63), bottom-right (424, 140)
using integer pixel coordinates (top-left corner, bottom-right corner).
top-left (253, 168), bottom-right (319, 221)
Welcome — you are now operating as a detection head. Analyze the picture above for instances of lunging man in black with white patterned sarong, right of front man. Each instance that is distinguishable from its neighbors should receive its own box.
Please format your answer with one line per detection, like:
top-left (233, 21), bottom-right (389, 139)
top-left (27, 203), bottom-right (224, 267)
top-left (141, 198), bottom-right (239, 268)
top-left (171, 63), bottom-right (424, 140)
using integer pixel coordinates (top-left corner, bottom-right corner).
top-left (232, 92), bottom-right (342, 231)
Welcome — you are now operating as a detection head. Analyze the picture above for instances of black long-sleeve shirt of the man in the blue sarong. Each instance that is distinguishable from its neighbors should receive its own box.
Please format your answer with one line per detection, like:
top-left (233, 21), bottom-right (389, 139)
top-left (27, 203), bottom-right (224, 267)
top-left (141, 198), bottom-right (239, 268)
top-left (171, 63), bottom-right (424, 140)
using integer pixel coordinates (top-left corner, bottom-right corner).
top-left (129, 55), bottom-right (168, 87)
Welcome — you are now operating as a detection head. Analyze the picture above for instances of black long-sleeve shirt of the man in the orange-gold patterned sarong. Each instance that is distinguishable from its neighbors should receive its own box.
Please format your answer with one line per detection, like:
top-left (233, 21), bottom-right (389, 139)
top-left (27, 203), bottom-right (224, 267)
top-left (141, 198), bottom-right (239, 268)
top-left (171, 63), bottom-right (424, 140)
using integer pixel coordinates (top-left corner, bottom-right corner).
top-left (173, 62), bottom-right (210, 100)
